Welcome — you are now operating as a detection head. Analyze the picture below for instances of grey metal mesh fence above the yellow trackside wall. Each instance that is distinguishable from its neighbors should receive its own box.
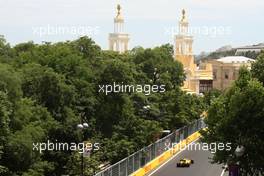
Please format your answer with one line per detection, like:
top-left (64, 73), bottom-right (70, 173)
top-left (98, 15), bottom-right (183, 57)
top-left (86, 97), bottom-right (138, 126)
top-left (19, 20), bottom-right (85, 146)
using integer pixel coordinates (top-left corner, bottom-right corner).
top-left (95, 119), bottom-right (205, 176)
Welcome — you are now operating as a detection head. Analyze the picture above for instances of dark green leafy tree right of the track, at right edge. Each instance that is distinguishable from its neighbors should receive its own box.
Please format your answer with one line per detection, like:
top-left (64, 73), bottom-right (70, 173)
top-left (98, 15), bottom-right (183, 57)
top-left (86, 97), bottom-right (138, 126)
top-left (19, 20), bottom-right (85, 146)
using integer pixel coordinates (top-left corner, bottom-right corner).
top-left (202, 68), bottom-right (264, 175)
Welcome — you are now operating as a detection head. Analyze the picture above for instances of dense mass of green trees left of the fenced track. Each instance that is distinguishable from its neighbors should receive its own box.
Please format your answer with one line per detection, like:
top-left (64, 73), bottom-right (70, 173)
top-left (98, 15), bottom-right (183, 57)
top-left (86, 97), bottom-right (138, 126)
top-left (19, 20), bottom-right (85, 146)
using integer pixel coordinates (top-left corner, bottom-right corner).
top-left (0, 37), bottom-right (205, 176)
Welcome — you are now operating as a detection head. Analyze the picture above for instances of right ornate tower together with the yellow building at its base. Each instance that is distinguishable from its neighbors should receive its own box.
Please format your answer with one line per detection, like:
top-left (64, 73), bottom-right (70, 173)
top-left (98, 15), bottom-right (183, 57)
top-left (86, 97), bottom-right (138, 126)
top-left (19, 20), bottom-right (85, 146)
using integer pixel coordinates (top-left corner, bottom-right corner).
top-left (175, 10), bottom-right (213, 94)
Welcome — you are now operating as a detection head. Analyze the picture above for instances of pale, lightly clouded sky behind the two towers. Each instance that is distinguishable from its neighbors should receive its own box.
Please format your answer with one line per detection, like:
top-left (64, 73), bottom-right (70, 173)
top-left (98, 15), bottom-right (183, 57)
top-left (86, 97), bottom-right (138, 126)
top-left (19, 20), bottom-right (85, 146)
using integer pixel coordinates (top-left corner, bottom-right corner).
top-left (0, 0), bottom-right (264, 54)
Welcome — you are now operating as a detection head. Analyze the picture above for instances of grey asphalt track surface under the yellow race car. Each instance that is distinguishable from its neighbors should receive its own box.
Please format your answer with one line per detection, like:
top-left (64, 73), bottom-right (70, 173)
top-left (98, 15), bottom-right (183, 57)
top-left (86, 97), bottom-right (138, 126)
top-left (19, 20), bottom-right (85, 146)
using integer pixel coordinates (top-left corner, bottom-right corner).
top-left (148, 142), bottom-right (227, 176)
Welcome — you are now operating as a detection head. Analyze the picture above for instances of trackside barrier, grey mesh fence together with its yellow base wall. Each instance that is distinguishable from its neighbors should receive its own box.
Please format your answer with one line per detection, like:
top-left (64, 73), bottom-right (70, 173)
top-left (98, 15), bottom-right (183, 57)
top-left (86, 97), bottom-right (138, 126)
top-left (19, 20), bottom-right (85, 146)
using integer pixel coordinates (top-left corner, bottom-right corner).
top-left (95, 119), bottom-right (205, 176)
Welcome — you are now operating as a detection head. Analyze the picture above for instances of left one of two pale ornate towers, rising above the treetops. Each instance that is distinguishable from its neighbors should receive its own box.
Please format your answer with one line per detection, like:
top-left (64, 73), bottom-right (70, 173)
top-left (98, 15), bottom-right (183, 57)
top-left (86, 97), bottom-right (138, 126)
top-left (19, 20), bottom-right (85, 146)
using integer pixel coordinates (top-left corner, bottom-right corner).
top-left (109, 4), bottom-right (129, 53)
